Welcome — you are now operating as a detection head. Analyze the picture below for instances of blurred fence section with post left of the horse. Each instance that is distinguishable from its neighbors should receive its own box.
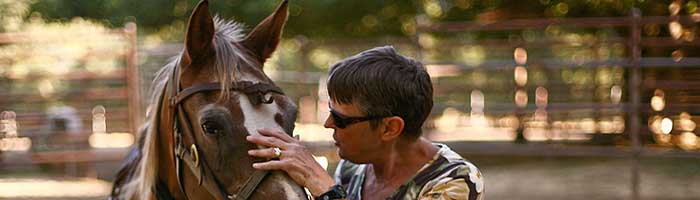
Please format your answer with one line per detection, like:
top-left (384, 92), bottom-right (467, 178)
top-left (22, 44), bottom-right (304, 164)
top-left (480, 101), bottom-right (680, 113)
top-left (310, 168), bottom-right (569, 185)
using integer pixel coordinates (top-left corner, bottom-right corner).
top-left (0, 23), bottom-right (142, 177)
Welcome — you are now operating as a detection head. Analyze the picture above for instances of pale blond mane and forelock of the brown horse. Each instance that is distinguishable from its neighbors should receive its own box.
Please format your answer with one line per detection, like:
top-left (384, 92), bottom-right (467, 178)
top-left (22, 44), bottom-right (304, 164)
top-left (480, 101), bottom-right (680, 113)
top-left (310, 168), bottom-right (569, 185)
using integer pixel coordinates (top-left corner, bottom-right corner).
top-left (110, 17), bottom-right (254, 199)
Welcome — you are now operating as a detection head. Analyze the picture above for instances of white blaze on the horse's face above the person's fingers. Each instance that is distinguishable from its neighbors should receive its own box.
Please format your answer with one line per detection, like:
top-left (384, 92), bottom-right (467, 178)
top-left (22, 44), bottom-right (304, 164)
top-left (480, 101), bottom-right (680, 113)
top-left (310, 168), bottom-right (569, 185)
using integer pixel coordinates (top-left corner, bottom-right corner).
top-left (238, 94), bottom-right (284, 144)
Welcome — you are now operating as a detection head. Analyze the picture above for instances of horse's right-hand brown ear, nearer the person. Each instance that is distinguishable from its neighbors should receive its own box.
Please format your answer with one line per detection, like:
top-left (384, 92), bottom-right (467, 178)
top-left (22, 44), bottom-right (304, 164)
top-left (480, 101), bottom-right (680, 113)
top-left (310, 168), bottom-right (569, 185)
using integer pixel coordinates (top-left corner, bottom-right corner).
top-left (242, 0), bottom-right (288, 67)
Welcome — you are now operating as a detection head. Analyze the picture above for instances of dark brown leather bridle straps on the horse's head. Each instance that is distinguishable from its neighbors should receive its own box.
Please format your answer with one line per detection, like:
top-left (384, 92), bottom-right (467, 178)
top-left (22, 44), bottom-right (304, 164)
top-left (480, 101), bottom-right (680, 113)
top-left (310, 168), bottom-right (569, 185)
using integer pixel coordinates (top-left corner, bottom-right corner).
top-left (169, 57), bottom-right (284, 200)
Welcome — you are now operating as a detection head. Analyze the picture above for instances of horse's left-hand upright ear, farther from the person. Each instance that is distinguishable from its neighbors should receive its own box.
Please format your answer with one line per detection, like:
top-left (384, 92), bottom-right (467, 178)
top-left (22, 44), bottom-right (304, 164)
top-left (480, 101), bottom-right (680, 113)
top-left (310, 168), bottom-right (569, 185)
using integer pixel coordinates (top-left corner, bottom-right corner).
top-left (185, 0), bottom-right (214, 61)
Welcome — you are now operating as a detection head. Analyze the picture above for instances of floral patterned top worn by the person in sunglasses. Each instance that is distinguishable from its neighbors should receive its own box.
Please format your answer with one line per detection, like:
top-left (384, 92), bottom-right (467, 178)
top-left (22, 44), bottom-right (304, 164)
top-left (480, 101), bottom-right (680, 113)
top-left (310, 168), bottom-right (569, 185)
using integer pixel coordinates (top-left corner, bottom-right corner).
top-left (335, 143), bottom-right (484, 200)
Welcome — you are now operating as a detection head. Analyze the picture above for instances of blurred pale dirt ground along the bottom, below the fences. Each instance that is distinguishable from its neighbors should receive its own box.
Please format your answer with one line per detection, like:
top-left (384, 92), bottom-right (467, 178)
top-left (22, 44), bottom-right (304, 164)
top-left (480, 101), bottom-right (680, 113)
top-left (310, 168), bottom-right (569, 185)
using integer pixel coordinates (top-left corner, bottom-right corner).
top-left (0, 155), bottom-right (700, 200)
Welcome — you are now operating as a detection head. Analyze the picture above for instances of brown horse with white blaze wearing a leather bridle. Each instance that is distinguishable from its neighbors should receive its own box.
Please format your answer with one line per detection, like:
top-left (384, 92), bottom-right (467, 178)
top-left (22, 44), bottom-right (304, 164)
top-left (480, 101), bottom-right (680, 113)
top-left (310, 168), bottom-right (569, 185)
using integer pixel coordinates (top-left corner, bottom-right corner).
top-left (110, 0), bottom-right (307, 200)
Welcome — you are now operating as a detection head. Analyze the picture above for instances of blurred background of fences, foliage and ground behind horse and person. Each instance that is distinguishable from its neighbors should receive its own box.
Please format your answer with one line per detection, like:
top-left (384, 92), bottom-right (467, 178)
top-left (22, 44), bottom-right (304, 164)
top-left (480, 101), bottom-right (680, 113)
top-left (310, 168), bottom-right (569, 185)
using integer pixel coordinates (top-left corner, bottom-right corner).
top-left (0, 0), bottom-right (700, 199)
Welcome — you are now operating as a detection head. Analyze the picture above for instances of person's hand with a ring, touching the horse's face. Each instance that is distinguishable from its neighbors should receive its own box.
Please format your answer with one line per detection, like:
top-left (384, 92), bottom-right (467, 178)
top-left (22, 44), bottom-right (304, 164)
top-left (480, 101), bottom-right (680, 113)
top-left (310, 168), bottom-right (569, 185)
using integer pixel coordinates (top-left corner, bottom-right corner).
top-left (246, 129), bottom-right (335, 196)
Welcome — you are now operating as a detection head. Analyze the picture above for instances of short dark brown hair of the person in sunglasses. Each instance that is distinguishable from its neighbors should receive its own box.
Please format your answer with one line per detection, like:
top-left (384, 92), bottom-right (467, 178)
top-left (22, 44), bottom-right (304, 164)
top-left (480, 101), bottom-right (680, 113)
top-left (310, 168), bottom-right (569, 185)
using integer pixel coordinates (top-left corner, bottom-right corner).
top-left (327, 46), bottom-right (433, 139)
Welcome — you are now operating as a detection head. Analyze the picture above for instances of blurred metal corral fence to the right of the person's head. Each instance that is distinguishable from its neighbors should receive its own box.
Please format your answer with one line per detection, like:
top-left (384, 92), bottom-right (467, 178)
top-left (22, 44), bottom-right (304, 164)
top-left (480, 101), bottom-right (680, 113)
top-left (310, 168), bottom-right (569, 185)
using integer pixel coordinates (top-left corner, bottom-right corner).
top-left (415, 9), bottom-right (700, 199)
